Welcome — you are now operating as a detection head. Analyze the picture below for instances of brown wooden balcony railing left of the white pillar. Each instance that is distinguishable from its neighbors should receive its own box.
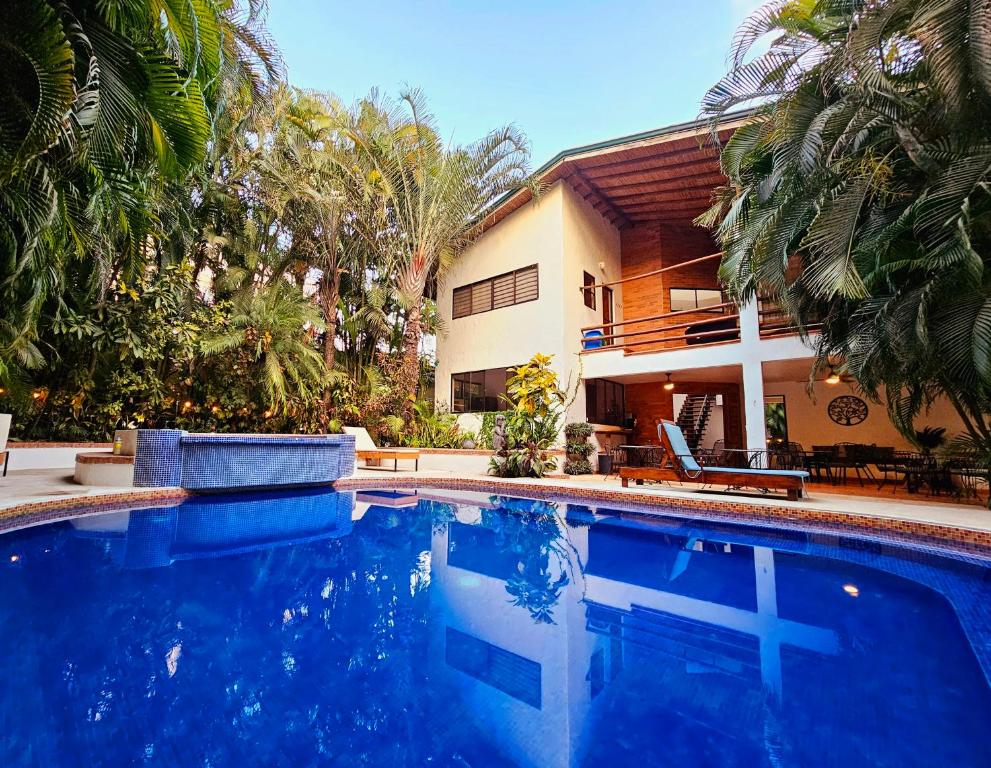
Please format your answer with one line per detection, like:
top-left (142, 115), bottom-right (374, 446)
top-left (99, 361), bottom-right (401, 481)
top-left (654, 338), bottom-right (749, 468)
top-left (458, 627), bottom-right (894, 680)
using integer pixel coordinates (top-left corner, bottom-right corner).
top-left (581, 302), bottom-right (740, 354)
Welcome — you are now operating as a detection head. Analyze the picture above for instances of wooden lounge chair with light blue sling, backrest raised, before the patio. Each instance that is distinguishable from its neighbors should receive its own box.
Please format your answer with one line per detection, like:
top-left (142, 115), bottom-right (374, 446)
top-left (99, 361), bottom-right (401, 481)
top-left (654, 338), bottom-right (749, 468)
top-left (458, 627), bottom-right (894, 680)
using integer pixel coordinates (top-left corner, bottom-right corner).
top-left (619, 421), bottom-right (809, 501)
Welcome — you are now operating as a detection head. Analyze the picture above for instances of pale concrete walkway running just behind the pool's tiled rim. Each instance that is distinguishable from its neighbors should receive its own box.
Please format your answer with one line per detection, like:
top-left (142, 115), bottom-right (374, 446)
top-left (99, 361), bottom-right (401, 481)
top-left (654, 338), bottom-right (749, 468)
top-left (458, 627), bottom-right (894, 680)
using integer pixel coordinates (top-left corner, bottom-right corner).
top-left (0, 469), bottom-right (991, 532)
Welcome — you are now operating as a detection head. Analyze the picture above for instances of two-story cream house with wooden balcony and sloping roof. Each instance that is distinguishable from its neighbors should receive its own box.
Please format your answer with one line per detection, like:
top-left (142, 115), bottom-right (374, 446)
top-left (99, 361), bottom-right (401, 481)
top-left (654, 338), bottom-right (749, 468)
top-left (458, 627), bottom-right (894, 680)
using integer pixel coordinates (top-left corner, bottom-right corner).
top-left (435, 117), bottom-right (959, 460)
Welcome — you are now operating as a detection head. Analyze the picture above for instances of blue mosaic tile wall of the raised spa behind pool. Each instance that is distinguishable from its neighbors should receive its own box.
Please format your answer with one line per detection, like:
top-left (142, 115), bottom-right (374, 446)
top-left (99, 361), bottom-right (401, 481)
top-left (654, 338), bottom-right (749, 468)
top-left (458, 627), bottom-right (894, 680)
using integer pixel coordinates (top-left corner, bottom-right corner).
top-left (134, 429), bottom-right (355, 491)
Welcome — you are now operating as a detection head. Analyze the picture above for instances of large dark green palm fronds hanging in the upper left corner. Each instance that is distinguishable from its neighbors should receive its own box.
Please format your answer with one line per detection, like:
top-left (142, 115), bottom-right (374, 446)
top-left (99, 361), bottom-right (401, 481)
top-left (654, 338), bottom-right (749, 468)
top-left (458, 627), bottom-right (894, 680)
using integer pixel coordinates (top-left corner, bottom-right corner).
top-left (0, 0), bottom-right (279, 380)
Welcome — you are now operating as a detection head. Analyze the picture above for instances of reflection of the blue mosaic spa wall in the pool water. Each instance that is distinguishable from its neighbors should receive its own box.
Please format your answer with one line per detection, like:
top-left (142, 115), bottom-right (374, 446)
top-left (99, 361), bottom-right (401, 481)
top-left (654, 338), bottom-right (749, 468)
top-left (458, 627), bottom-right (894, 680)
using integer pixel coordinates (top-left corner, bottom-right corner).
top-left (72, 491), bottom-right (355, 568)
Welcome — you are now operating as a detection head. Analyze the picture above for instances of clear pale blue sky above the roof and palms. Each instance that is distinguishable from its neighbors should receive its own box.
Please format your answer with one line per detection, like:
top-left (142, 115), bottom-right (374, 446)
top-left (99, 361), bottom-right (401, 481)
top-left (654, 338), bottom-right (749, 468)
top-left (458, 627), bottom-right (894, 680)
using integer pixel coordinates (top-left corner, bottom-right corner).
top-left (269, 0), bottom-right (760, 166)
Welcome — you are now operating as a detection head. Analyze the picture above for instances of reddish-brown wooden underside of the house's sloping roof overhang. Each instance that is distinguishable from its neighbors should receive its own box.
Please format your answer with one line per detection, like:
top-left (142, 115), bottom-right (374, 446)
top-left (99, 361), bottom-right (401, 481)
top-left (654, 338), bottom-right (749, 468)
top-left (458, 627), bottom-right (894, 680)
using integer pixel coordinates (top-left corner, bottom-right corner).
top-left (482, 115), bottom-right (748, 230)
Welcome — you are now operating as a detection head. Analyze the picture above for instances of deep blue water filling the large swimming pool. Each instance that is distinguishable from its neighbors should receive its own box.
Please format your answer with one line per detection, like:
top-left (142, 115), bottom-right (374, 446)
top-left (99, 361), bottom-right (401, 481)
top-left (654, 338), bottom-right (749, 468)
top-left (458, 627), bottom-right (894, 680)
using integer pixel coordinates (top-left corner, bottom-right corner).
top-left (0, 491), bottom-right (991, 768)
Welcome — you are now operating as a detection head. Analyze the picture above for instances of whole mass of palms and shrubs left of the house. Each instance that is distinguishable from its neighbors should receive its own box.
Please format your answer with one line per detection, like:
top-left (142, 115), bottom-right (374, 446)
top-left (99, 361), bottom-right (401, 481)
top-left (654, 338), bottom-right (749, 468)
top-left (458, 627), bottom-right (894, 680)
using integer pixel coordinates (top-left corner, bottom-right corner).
top-left (0, 6), bottom-right (527, 440)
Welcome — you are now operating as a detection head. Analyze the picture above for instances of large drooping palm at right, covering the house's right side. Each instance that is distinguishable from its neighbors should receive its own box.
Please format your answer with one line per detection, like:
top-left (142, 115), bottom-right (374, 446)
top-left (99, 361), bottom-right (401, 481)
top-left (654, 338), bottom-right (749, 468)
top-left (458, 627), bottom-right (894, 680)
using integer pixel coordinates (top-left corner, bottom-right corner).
top-left (701, 0), bottom-right (991, 443)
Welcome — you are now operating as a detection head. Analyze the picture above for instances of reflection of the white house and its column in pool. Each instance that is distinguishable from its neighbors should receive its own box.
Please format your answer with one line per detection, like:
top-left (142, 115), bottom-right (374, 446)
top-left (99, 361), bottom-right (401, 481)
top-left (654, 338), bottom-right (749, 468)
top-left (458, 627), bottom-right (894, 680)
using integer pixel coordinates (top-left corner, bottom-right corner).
top-left (432, 504), bottom-right (838, 766)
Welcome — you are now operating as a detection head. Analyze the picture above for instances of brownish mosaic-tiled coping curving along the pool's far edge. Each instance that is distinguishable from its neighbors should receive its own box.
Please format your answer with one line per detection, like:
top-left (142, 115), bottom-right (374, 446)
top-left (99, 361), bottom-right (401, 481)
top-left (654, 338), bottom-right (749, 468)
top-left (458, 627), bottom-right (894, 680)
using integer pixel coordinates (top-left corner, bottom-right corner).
top-left (0, 475), bottom-right (991, 559)
